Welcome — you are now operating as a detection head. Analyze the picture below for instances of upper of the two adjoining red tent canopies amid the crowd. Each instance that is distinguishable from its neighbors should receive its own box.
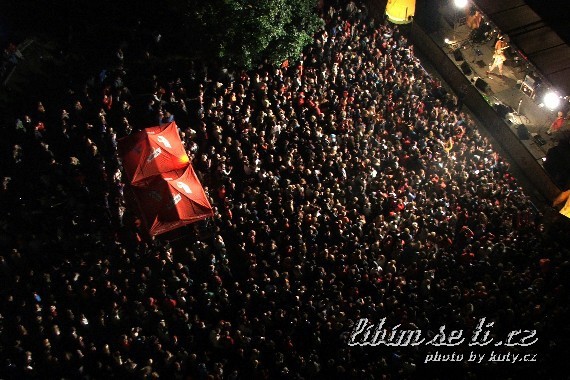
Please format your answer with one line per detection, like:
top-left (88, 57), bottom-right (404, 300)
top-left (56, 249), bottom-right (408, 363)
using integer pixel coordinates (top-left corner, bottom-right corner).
top-left (118, 122), bottom-right (190, 186)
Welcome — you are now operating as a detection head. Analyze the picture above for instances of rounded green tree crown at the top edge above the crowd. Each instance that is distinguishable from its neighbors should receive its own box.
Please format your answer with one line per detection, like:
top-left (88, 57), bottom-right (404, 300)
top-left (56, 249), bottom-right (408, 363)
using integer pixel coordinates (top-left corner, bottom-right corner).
top-left (186, 0), bottom-right (322, 67)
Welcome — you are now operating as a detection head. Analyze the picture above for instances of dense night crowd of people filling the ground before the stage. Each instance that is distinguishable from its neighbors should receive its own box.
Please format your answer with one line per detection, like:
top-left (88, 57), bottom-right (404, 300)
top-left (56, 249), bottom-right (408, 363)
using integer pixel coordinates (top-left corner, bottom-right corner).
top-left (0, 3), bottom-right (570, 379)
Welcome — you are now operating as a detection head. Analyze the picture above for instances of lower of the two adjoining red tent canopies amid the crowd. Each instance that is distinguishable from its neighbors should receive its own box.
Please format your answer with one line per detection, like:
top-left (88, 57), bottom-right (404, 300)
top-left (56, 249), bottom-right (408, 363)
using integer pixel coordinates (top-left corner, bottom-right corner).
top-left (132, 165), bottom-right (213, 235)
